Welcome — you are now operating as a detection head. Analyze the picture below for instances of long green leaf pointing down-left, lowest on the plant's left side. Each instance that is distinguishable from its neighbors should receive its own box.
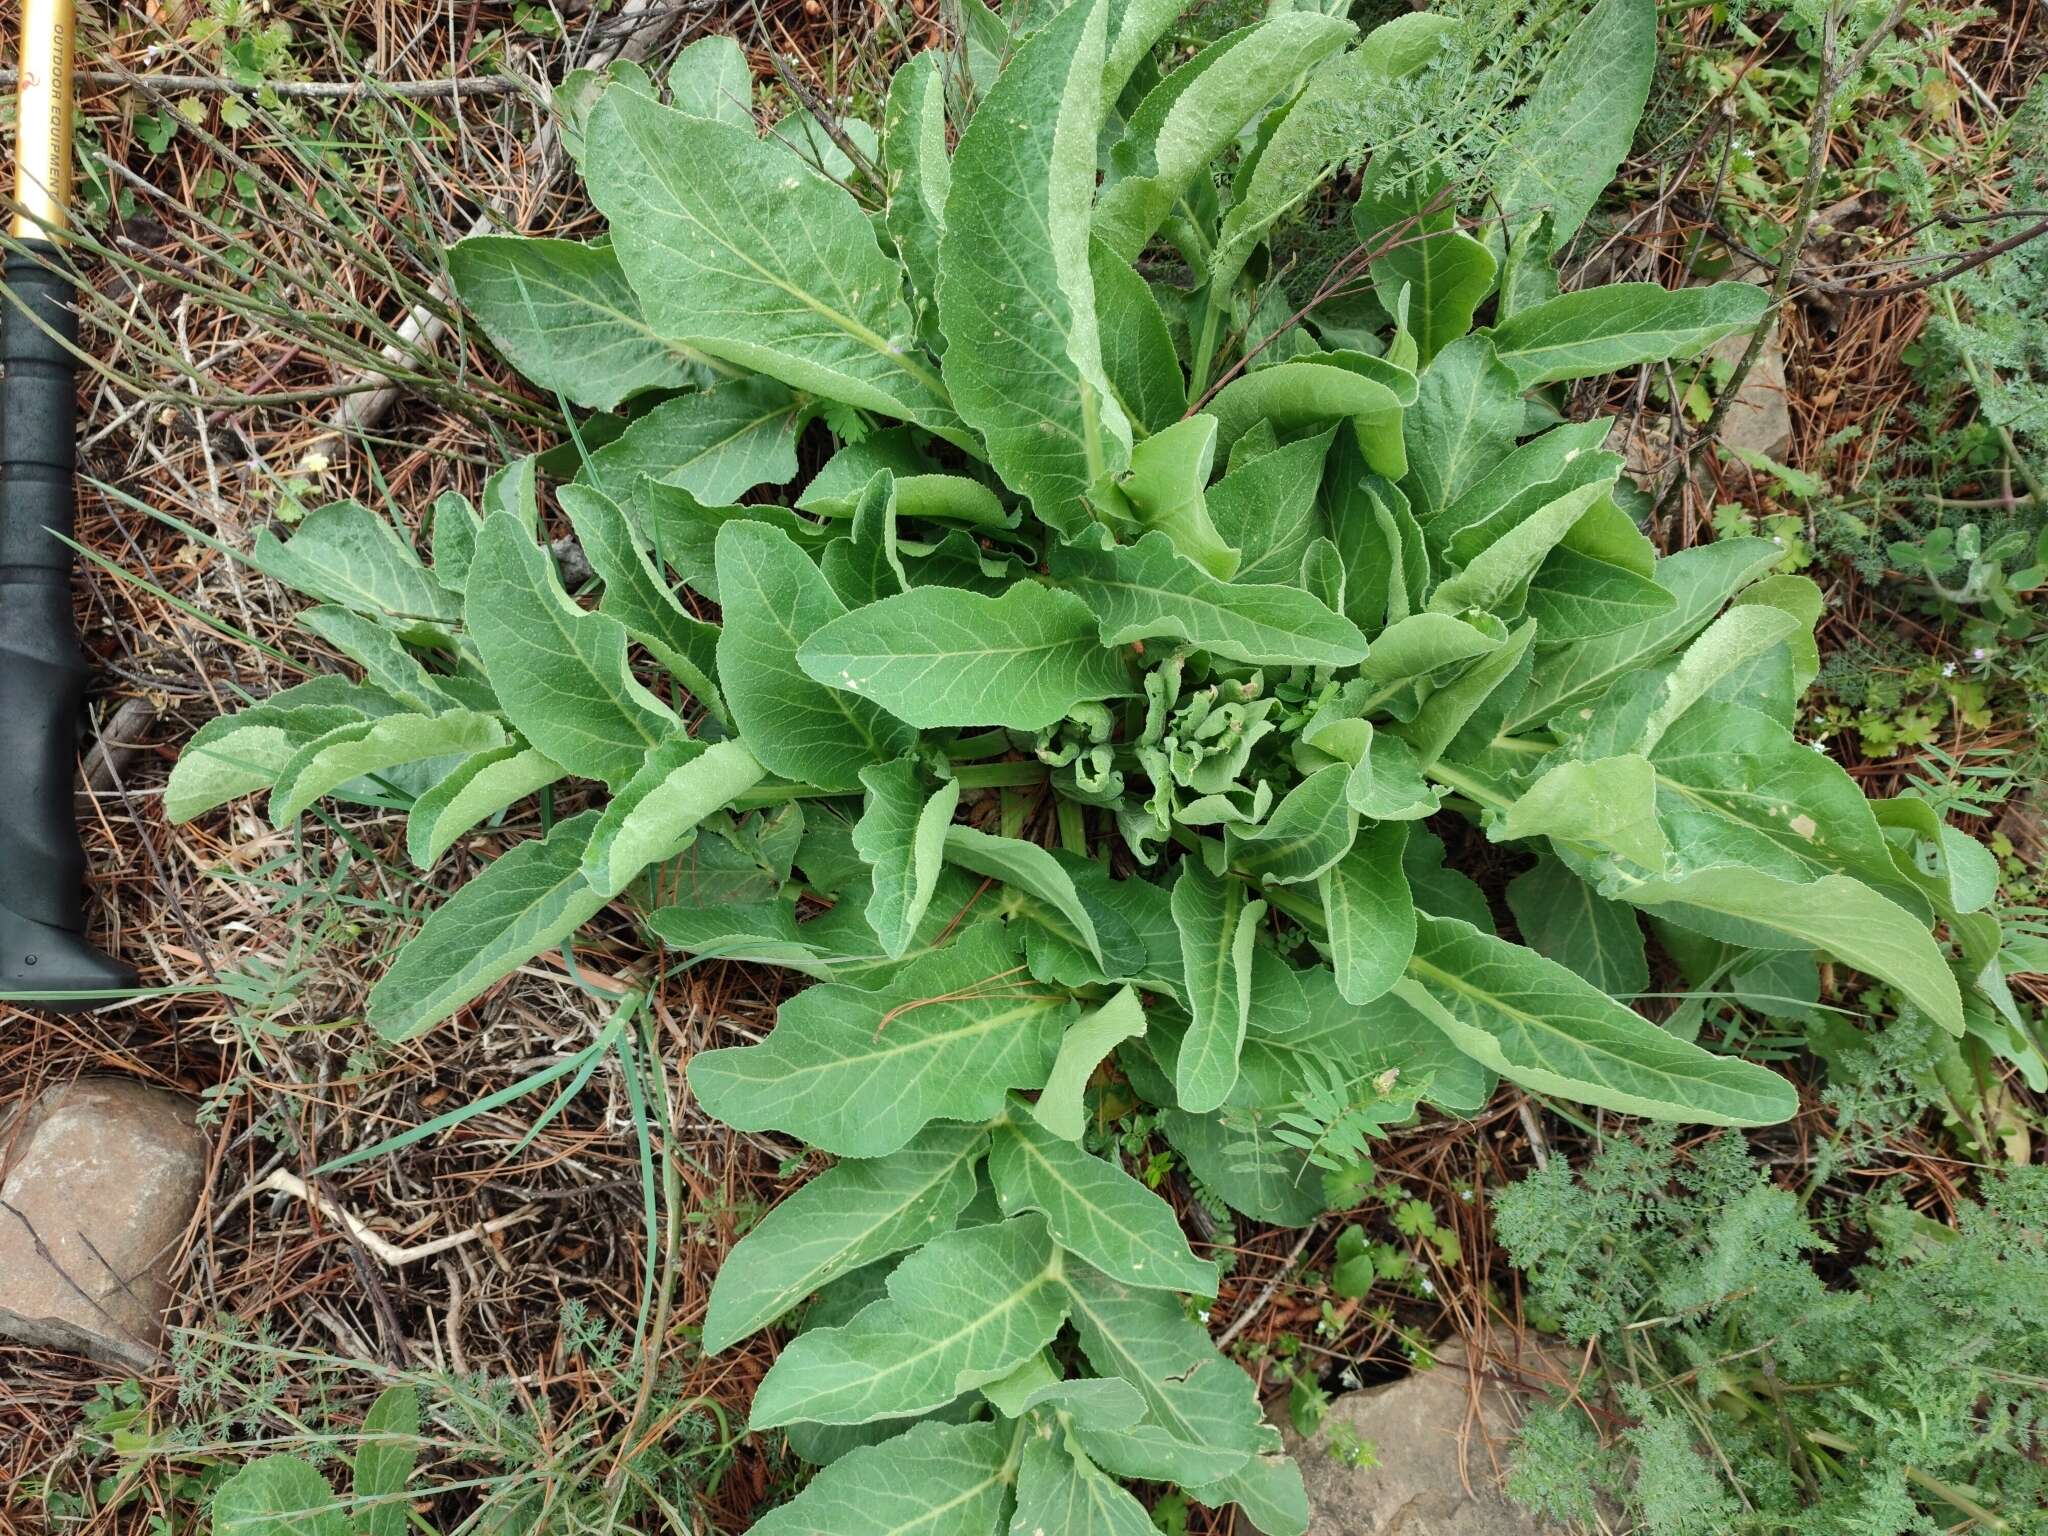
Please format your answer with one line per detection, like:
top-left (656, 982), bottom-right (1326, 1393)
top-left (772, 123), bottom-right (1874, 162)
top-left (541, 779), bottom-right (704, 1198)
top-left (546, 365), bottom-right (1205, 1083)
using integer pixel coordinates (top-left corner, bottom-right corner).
top-left (367, 811), bottom-right (604, 1040)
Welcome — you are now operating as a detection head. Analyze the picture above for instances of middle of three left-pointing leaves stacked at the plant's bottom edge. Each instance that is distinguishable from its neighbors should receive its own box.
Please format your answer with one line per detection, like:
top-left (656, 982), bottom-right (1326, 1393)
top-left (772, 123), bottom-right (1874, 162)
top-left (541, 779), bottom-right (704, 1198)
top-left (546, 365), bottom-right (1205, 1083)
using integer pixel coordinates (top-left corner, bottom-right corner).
top-left (748, 1217), bottom-right (1067, 1430)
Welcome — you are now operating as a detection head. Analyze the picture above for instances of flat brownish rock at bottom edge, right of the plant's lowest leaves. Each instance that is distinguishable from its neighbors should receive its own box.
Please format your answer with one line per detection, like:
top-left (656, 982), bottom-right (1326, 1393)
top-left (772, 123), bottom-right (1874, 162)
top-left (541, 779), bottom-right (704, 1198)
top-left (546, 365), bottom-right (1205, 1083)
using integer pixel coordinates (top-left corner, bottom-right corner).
top-left (1286, 1343), bottom-right (1561, 1536)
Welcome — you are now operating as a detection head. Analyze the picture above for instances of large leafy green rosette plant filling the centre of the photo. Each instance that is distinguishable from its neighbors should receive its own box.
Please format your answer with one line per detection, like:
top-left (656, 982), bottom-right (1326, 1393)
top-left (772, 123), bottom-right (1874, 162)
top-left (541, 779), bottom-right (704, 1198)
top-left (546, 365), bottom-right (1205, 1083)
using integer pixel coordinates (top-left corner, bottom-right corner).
top-left (168, 0), bottom-right (2011, 1536)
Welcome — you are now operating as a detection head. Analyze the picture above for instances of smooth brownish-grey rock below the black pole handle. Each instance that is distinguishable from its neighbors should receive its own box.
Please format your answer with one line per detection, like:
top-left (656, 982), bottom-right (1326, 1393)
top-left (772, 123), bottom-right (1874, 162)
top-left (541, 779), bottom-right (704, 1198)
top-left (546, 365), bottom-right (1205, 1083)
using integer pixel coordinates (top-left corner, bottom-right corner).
top-left (0, 1077), bottom-right (207, 1370)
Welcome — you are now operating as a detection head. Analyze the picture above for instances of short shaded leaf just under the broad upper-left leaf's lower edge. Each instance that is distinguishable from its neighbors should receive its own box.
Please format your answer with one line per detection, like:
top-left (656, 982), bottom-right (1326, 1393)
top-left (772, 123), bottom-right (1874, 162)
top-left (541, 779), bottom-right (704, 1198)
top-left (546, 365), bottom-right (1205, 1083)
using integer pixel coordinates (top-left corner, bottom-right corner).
top-left (578, 379), bottom-right (801, 506)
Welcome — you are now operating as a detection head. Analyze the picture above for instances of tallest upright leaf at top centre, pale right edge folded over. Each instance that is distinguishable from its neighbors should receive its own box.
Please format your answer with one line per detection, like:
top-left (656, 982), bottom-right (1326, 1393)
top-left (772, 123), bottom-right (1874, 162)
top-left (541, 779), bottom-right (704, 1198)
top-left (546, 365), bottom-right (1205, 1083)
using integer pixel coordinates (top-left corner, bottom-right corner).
top-left (938, 0), bottom-right (1130, 539)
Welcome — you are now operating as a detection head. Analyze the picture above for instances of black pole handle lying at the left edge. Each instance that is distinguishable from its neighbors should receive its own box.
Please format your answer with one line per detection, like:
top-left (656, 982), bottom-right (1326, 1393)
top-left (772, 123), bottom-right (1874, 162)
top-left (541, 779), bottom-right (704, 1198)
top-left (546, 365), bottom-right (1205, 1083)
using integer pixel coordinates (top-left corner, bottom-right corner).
top-left (0, 242), bottom-right (135, 1008)
